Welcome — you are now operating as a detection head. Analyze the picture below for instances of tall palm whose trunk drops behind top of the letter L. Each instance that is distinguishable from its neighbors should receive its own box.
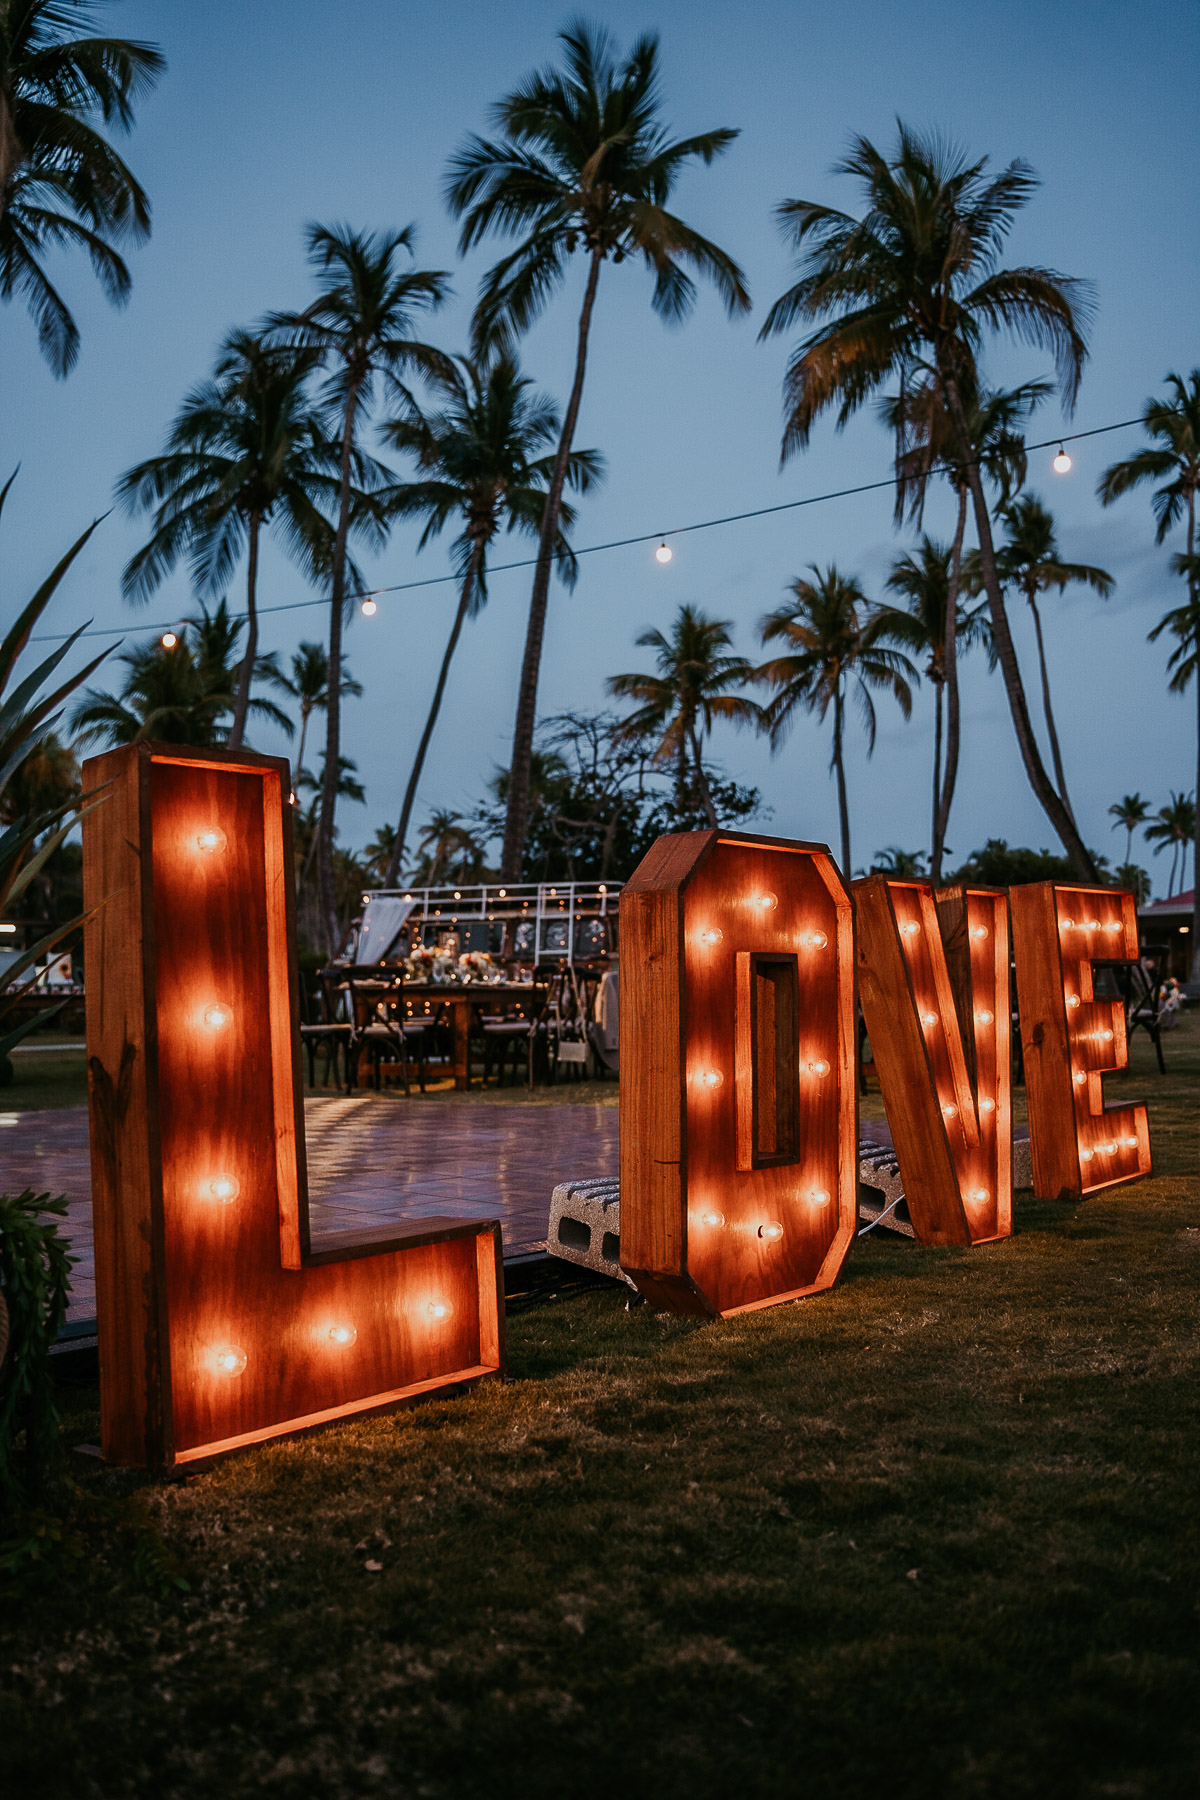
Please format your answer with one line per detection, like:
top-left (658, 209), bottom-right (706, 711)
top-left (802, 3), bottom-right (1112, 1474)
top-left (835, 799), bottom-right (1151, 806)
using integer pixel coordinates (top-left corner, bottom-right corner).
top-left (117, 331), bottom-right (371, 751)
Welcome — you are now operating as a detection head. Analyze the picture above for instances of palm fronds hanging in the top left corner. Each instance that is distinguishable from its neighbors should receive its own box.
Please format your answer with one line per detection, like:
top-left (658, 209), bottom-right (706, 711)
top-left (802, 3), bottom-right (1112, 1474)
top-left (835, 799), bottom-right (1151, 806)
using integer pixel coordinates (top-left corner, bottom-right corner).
top-left (0, 0), bottom-right (166, 378)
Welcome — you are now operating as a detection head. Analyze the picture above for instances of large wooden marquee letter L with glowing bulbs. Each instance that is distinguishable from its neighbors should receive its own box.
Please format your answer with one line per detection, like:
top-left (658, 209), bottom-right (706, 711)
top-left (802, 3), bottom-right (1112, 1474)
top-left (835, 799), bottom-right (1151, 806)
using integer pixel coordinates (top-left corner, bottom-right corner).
top-left (83, 743), bottom-right (504, 1469)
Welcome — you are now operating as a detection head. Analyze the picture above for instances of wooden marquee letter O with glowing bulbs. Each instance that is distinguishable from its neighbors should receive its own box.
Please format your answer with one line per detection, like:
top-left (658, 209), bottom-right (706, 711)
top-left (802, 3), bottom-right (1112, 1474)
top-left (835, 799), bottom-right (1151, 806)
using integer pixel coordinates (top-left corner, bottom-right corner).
top-left (621, 832), bottom-right (858, 1316)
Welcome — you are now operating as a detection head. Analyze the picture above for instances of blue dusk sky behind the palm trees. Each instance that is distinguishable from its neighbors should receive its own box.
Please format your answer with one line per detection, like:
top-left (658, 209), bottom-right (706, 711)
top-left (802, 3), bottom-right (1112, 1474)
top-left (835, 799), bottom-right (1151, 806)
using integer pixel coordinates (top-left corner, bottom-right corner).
top-left (0, 0), bottom-right (1200, 893)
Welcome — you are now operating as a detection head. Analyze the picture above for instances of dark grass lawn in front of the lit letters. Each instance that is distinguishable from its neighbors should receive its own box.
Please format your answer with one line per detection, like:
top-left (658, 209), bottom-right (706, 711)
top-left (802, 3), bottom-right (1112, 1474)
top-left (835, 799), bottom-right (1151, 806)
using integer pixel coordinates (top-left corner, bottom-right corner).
top-left (0, 1021), bottom-right (1200, 1800)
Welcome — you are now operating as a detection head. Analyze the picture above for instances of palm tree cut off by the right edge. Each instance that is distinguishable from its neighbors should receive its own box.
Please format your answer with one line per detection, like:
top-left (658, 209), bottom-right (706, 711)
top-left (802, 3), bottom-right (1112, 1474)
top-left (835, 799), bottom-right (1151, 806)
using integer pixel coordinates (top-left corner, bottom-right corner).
top-left (1096, 367), bottom-right (1200, 990)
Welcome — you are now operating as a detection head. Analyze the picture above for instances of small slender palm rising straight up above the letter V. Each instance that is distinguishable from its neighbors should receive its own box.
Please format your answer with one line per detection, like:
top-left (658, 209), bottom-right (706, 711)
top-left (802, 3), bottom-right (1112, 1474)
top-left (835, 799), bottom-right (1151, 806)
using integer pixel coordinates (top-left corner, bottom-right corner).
top-left (885, 533), bottom-right (991, 882)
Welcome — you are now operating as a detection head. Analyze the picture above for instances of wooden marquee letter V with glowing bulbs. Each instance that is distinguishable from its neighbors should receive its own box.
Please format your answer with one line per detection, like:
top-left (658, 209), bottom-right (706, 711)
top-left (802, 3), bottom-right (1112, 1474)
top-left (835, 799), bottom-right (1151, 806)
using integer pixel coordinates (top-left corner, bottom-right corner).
top-left (855, 875), bottom-right (1013, 1244)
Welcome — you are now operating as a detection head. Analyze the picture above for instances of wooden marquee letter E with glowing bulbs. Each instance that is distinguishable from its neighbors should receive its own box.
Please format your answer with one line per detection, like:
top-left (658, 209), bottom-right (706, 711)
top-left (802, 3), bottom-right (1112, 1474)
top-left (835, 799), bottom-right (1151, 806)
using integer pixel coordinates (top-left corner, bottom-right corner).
top-left (1009, 882), bottom-right (1150, 1199)
